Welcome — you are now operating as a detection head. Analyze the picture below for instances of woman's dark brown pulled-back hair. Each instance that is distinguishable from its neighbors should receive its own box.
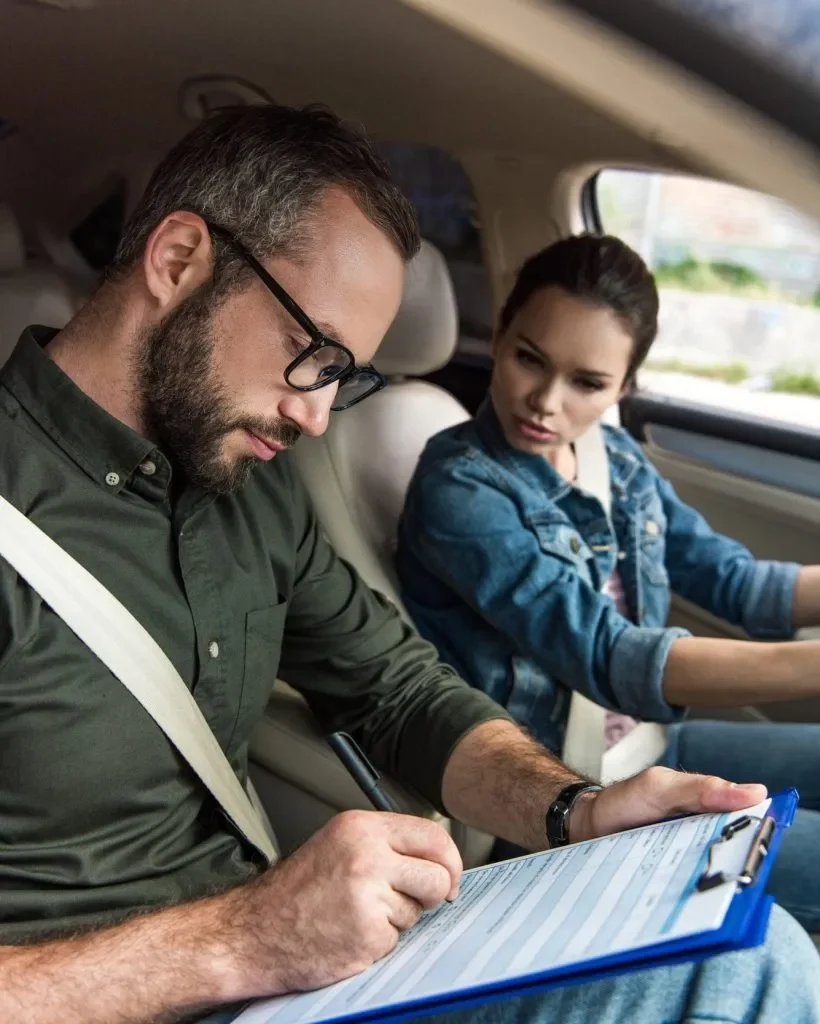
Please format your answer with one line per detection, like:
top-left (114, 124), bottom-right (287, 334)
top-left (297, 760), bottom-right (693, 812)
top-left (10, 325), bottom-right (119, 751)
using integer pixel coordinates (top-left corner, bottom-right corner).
top-left (499, 234), bottom-right (658, 384)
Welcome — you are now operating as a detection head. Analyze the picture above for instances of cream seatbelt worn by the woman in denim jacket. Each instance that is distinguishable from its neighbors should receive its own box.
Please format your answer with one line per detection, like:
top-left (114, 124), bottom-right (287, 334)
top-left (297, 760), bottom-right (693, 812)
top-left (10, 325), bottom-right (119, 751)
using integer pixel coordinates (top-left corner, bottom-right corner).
top-left (562, 423), bottom-right (666, 782)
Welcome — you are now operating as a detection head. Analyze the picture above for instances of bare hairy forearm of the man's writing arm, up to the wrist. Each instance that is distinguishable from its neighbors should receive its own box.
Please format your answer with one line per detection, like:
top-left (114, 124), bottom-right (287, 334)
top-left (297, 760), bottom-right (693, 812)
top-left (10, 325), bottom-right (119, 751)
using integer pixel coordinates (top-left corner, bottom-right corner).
top-left (0, 894), bottom-right (243, 1024)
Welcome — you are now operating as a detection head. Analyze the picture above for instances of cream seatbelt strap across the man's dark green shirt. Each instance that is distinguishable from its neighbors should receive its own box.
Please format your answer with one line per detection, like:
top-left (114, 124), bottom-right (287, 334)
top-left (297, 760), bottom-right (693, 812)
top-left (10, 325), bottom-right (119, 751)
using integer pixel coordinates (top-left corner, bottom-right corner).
top-left (0, 497), bottom-right (277, 864)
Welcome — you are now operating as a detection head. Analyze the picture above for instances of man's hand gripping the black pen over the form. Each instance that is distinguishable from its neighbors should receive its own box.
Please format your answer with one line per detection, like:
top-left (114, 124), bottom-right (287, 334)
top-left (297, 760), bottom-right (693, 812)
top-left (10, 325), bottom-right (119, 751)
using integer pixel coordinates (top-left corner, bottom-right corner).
top-left (225, 811), bottom-right (462, 996)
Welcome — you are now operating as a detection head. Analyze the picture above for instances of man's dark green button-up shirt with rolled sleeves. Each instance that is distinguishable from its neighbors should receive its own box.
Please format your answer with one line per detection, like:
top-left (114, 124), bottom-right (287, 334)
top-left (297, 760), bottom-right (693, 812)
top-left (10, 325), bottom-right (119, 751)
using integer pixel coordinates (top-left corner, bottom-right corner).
top-left (0, 329), bottom-right (502, 943)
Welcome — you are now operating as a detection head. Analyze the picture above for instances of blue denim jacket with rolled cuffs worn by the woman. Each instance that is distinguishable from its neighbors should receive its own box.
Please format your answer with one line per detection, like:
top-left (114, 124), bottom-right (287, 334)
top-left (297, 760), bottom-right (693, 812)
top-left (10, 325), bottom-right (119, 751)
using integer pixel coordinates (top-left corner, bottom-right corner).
top-left (397, 401), bottom-right (799, 752)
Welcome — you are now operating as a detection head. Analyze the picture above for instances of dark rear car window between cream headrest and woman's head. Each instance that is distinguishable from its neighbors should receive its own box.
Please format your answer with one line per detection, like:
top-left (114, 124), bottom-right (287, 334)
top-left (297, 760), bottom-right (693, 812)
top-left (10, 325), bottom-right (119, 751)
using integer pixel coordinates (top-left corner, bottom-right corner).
top-left (380, 142), bottom-right (492, 351)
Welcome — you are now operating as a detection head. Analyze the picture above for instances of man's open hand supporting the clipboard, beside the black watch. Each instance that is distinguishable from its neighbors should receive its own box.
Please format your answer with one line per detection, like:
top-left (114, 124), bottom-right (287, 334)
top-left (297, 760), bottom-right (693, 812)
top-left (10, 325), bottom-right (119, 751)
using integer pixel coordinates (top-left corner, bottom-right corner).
top-left (569, 768), bottom-right (766, 842)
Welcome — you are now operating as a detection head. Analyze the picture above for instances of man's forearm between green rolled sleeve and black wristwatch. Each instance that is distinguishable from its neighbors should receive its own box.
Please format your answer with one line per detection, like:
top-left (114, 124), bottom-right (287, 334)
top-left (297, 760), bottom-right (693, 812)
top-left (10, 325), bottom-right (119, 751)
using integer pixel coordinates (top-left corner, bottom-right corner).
top-left (441, 720), bottom-right (580, 850)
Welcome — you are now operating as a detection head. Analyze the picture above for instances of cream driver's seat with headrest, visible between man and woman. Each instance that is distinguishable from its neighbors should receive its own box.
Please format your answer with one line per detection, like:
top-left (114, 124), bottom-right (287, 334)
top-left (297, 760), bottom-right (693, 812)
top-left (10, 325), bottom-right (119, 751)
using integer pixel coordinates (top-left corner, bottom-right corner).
top-left (251, 242), bottom-right (491, 866)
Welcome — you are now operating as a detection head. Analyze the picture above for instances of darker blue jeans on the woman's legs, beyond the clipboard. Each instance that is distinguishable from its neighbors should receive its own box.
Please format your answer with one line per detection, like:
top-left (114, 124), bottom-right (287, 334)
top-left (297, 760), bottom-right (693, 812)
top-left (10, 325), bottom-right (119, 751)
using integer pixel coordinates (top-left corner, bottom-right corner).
top-left (660, 719), bottom-right (820, 932)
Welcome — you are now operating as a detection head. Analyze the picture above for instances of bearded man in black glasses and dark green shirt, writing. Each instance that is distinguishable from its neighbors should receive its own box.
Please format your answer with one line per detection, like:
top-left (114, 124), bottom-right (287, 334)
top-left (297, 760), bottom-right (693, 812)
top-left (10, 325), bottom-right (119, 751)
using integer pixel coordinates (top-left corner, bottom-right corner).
top-left (0, 108), bottom-right (820, 1024)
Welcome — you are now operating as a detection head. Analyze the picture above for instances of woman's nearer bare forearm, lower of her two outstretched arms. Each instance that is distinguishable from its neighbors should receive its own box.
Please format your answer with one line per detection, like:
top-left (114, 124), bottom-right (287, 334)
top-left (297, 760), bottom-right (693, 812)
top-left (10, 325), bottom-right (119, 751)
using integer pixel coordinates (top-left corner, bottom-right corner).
top-left (663, 637), bottom-right (820, 708)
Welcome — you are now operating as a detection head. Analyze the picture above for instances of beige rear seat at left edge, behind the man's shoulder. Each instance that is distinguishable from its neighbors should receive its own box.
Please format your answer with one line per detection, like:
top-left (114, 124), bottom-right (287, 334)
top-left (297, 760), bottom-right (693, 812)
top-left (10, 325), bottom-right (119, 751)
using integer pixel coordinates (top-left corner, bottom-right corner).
top-left (0, 203), bottom-right (81, 366)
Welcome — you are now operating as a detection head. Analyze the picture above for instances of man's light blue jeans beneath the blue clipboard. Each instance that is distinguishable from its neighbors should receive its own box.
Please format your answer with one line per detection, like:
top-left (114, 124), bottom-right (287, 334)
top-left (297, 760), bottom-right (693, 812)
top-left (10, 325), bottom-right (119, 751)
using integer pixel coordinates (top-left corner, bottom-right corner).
top-left (203, 906), bottom-right (820, 1024)
